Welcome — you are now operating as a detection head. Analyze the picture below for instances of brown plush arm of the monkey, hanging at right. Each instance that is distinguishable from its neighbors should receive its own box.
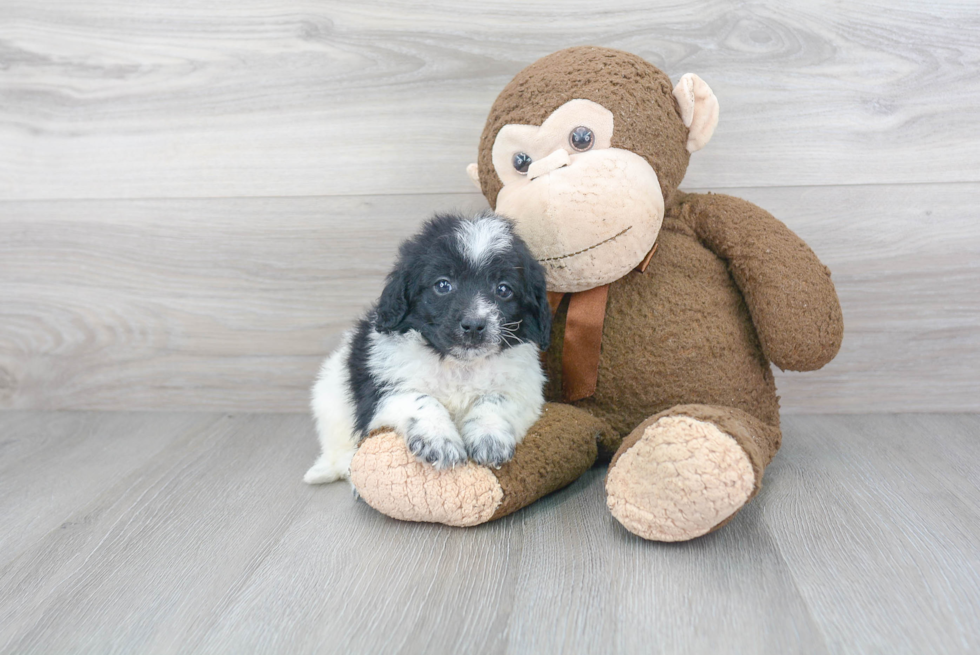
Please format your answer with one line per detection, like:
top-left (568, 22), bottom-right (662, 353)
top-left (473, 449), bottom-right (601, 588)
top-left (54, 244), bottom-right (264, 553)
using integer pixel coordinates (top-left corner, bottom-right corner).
top-left (686, 194), bottom-right (844, 371)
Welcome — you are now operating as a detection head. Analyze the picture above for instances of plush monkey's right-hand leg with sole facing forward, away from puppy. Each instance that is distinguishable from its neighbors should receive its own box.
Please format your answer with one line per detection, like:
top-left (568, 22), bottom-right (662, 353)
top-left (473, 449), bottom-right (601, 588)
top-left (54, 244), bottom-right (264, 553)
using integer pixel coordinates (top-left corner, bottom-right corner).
top-left (606, 405), bottom-right (782, 541)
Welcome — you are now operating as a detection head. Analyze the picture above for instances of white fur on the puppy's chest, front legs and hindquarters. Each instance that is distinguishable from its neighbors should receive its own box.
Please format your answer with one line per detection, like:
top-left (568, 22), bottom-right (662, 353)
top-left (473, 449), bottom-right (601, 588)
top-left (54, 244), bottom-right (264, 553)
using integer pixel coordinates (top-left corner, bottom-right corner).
top-left (303, 331), bottom-right (544, 484)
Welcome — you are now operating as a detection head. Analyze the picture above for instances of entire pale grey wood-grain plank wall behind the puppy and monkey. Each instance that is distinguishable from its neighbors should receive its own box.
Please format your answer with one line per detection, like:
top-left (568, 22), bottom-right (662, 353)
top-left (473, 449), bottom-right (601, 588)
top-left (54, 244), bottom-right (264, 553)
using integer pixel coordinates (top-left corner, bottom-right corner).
top-left (0, 0), bottom-right (980, 412)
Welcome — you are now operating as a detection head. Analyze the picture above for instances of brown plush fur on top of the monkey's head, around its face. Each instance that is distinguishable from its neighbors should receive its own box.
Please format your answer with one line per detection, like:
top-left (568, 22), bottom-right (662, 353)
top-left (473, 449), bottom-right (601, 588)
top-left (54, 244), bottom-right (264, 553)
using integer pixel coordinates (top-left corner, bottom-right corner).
top-left (477, 46), bottom-right (690, 207)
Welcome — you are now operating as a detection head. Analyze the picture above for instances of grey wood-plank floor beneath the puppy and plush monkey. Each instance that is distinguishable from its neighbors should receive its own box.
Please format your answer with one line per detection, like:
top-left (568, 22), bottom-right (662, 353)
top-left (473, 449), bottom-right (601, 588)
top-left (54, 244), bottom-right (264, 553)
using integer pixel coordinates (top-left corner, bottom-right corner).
top-left (0, 411), bottom-right (980, 654)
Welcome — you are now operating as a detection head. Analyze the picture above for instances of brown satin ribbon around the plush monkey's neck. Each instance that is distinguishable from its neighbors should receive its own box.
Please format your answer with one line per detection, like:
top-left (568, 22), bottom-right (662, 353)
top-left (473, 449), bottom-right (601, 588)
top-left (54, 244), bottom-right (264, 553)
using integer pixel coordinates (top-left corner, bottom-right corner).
top-left (548, 244), bottom-right (657, 402)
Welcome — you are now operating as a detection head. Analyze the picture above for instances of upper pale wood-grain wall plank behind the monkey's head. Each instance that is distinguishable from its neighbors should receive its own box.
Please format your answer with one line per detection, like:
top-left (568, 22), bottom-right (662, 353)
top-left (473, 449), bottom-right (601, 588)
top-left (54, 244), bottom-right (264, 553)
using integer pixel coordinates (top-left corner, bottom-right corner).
top-left (0, 0), bottom-right (980, 199)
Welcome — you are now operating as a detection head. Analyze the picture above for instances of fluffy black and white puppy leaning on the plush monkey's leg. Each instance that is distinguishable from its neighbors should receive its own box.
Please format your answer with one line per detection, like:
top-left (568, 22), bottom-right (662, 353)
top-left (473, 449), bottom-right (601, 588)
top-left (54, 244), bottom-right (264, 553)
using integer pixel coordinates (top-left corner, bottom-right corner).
top-left (303, 212), bottom-right (551, 484)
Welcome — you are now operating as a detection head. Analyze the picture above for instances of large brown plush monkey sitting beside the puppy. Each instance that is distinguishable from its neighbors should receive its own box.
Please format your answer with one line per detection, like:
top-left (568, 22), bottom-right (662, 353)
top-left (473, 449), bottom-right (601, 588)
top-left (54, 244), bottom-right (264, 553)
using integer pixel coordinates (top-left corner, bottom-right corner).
top-left (351, 47), bottom-right (843, 541)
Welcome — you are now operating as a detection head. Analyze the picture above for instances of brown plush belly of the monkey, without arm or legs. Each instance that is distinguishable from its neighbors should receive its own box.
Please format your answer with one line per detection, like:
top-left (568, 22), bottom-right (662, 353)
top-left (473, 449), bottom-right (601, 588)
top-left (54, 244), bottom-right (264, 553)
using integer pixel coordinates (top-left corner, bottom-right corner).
top-left (548, 229), bottom-right (779, 434)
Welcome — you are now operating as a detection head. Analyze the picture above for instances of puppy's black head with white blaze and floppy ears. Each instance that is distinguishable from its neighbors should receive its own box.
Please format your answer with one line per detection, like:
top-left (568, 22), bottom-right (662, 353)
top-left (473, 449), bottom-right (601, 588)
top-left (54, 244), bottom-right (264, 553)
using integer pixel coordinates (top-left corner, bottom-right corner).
top-left (375, 213), bottom-right (551, 359)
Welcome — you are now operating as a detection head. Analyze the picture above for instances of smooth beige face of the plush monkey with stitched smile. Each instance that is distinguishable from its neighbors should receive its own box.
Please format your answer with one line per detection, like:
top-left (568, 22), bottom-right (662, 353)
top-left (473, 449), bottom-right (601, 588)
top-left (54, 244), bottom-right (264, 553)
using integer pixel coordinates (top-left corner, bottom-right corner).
top-left (492, 99), bottom-right (664, 292)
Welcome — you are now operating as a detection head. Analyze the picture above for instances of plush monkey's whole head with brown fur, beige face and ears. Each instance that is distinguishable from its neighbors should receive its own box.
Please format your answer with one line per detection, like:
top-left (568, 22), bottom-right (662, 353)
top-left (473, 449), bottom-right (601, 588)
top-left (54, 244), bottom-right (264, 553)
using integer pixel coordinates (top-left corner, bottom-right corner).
top-left (467, 47), bottom-right (718, 291)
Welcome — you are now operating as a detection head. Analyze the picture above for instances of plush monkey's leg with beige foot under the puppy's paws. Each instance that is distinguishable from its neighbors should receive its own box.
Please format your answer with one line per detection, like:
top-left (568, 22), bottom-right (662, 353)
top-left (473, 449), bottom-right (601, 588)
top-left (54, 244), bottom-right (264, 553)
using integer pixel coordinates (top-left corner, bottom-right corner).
top-left (350, 403), bottom-right (612, 526)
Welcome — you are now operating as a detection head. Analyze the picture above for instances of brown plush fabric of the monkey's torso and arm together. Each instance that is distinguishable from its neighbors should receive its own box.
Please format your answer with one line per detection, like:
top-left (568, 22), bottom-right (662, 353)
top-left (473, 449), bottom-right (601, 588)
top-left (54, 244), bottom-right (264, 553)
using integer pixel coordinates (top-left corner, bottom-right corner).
top-left (546, 194), bottom-right (843, 435)
